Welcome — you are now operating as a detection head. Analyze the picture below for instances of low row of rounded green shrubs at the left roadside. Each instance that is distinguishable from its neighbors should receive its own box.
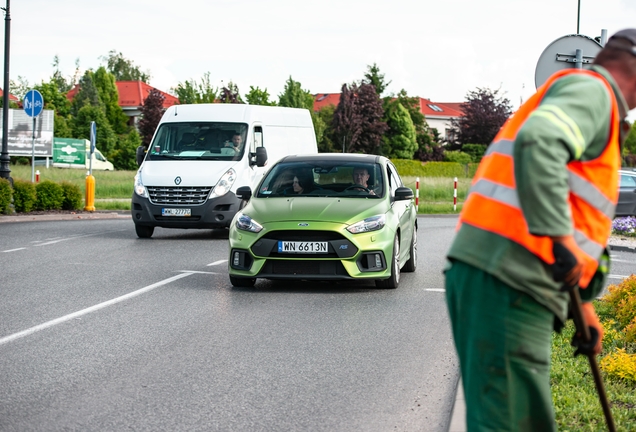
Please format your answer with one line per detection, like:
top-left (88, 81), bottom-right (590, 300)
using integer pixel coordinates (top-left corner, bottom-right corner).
top-left (0, 179), bottom-right (82, 214)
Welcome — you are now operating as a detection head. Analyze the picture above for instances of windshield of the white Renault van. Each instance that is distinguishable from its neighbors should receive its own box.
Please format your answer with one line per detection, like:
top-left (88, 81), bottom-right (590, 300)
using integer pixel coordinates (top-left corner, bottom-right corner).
top-left (146, 122), bottom-right (247, 160)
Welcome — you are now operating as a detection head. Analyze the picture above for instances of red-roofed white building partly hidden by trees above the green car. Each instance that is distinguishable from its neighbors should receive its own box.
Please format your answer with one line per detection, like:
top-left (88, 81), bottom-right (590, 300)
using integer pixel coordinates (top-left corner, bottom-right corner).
top-left (314, 93), bottom-right (463, 140)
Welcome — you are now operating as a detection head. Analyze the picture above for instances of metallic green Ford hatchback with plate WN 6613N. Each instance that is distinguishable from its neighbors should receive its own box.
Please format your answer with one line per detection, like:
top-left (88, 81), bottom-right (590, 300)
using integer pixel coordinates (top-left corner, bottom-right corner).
top-left (228, 153), bottom-right (417, 288)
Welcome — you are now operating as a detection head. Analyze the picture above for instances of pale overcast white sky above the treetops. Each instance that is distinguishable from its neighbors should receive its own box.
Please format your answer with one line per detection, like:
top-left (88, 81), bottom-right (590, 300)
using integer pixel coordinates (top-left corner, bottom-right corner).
top-left (0, 0), bottom-right (636, 115)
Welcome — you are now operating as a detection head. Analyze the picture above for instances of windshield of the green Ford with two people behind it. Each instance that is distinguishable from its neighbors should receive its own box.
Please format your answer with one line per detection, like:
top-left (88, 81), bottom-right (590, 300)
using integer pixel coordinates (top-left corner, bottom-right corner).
top-left (257, 161), bottom-right (384, 198)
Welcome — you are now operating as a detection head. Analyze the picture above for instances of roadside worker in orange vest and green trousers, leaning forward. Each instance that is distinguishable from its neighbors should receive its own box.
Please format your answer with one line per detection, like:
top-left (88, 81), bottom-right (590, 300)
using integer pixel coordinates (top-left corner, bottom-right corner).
top-left (445, 29), bottom-right (636, 431)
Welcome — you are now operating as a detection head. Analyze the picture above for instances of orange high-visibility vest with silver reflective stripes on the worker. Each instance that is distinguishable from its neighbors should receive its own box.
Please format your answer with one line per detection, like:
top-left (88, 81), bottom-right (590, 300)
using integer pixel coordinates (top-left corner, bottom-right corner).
top-left (458, 69), bottom-right (621, 288)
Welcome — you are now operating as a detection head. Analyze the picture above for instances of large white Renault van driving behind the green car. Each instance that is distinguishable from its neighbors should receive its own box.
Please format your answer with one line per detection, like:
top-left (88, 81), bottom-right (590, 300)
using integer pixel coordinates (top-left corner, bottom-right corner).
top-left (131, 104), bottom-right (318, 238)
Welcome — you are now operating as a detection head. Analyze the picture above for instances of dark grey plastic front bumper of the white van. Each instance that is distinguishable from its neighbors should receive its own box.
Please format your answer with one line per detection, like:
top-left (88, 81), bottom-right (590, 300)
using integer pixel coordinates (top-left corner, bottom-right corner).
top-left (130, 192), bottom-right (241, 229)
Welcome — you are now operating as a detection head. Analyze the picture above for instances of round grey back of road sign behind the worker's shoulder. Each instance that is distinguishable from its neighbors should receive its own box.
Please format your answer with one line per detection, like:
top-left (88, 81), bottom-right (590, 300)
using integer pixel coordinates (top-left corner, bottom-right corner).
top-left (534, 34), bottom-right (603, 88)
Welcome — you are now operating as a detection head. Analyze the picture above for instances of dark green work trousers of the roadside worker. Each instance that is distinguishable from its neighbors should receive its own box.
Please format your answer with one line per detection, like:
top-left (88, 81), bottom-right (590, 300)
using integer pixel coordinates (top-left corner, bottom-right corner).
top-left (445, 261), bottom-right (556, 431)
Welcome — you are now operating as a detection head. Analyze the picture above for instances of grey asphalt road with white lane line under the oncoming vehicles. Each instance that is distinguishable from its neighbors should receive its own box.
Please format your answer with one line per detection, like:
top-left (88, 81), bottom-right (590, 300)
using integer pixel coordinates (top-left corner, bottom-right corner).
top-left (0, 217), bottom-right (458, 431)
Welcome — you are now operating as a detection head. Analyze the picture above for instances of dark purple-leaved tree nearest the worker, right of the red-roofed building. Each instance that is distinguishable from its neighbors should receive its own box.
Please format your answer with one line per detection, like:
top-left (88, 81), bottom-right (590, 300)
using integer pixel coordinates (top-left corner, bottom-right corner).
top-left (451, 87), bottom-right (512, 149)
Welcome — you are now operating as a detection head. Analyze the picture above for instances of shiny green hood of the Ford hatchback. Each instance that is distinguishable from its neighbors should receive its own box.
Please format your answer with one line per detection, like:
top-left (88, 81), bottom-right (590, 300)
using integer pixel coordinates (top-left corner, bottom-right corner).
top-left (243, 197), bottom-right (389, 224)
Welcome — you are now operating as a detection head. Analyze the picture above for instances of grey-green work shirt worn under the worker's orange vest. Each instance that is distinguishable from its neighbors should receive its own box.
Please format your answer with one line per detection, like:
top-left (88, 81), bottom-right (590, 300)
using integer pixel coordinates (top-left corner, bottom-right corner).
top-left (448, 66), bottom-right (628, 321)
